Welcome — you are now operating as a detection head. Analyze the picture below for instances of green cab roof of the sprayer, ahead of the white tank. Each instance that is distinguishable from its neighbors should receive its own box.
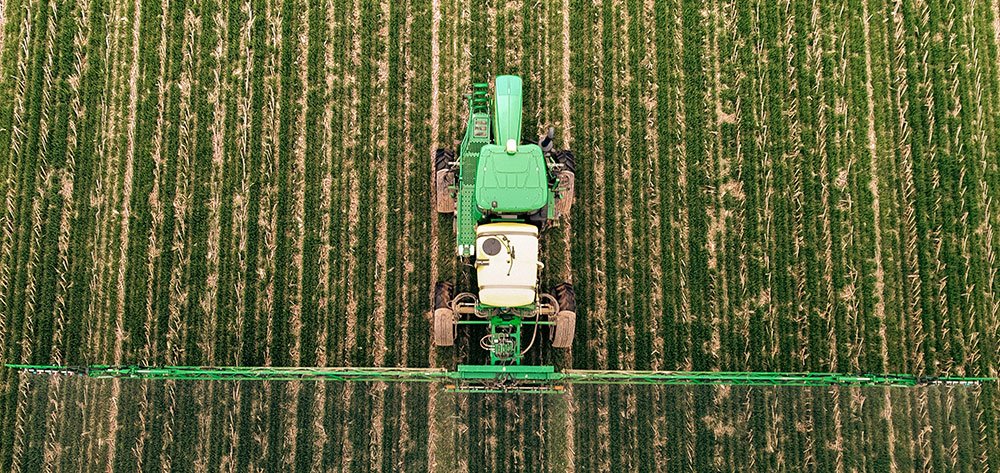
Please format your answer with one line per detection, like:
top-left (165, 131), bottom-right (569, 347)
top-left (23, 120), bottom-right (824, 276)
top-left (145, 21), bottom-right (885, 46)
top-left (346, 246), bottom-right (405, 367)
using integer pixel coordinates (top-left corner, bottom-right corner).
top-left (476, 144), bottom-right (548, 213)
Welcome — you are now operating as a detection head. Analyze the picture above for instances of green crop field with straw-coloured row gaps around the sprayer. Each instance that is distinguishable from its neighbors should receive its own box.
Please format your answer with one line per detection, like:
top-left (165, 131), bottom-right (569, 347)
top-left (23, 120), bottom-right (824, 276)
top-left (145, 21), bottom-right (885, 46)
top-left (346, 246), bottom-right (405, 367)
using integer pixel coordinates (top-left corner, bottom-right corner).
top-left (0, 0), bottom-right (1000, 472)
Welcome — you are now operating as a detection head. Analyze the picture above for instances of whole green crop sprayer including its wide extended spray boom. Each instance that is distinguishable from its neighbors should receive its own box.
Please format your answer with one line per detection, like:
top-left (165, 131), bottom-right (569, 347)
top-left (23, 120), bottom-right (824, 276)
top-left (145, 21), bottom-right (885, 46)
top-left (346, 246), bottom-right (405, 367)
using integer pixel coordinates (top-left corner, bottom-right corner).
top-left (7, 76), bottom-right (996, 393)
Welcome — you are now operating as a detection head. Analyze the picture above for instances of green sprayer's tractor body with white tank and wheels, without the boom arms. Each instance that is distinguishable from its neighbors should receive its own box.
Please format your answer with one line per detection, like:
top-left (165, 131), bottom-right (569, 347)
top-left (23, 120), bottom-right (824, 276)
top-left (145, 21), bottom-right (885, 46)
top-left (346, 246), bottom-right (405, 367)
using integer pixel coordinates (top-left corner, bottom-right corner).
top-left (434, 76), bottom-right (576, 377)
